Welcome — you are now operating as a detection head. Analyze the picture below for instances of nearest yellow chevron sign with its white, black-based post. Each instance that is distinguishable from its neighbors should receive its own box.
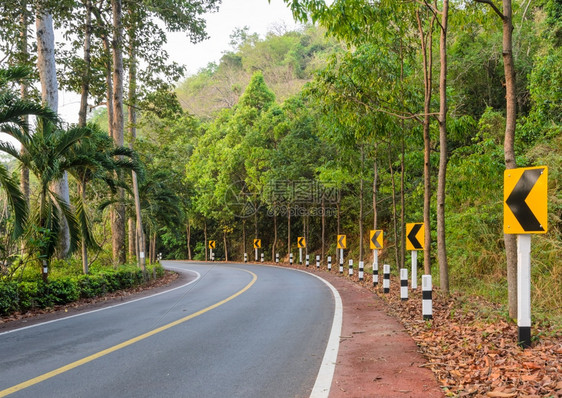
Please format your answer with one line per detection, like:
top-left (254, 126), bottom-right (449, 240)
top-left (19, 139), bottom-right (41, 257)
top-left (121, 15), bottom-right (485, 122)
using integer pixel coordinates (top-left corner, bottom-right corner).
top-left (503, 166), bottom-right (548, 348)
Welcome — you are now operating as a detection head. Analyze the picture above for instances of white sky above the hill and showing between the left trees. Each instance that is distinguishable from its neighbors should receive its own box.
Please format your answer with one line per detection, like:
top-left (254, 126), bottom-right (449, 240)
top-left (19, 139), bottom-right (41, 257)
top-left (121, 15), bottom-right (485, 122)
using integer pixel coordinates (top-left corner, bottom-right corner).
top-left (55, 0), bottom-right (298, 123)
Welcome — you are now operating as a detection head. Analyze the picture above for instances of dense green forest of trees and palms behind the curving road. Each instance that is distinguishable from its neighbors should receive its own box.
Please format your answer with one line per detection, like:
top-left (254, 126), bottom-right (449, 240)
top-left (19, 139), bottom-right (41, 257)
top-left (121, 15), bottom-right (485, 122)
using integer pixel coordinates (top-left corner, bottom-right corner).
top-left (0, 0), bottom-right (562, 324)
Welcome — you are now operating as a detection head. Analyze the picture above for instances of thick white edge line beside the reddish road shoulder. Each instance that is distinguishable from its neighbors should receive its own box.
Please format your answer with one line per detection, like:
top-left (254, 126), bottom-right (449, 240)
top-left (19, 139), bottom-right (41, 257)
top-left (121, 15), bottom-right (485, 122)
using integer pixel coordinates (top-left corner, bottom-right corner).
top-left (306, 272), bottom-right (343, 398)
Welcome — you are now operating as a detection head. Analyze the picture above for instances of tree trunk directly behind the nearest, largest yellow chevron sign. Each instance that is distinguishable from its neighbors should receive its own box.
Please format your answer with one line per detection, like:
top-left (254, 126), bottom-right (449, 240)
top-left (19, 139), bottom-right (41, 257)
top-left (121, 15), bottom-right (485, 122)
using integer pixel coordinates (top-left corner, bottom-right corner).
top-left (475, 0), bottom-right (517, 318)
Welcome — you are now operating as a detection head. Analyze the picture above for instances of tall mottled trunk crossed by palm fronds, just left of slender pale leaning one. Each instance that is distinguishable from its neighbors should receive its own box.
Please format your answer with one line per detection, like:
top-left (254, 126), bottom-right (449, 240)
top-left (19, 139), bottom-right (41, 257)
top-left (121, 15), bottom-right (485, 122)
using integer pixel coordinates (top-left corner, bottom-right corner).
top-left (111, 0), bottom-right (124, 264)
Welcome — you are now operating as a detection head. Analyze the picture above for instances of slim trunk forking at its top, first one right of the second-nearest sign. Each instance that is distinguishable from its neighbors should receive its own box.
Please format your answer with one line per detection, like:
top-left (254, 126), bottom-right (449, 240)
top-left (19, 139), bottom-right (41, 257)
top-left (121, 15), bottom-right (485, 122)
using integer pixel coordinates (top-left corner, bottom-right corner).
top-left (416, 10), bottom-right (435, 275)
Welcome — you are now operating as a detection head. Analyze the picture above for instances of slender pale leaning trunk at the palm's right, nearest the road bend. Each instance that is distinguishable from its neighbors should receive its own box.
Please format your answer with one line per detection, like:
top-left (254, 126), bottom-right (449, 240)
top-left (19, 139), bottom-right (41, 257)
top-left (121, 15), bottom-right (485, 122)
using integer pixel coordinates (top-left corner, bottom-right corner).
top-left (128, 18), bottom-right (146, 273)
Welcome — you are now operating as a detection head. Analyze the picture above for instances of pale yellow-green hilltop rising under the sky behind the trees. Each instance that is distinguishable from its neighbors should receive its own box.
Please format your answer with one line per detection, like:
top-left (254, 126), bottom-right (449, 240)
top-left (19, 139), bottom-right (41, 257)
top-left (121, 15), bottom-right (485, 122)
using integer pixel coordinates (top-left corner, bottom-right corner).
top-left (176, 26), bottom-right (341, 118)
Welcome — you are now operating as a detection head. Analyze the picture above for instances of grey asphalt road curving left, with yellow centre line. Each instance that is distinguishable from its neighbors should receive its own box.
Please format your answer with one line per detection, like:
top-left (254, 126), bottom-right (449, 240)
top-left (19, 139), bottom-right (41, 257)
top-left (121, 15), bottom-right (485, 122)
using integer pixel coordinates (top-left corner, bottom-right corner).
top-left (0, 262), bottom-right (334, 398)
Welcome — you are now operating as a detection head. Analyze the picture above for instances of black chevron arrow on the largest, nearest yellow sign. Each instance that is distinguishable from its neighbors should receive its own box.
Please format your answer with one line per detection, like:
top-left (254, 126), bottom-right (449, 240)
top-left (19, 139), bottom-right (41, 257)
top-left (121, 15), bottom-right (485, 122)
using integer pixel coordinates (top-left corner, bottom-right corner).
top-left (505, 168), bottom-right (544, 232)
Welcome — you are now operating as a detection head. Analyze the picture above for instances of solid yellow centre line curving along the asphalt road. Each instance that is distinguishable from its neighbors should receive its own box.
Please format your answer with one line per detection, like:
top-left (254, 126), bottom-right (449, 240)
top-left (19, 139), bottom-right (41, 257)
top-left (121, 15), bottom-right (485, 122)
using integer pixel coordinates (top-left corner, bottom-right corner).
top-left (0, 268), bottom-right (258, 398)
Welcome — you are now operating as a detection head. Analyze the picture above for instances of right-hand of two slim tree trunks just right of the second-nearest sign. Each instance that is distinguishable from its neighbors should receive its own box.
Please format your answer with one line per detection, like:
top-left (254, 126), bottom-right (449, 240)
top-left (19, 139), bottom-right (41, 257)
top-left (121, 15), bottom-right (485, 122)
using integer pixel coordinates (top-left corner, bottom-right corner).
top-left (437, 0), bottom-right (449, 294)
